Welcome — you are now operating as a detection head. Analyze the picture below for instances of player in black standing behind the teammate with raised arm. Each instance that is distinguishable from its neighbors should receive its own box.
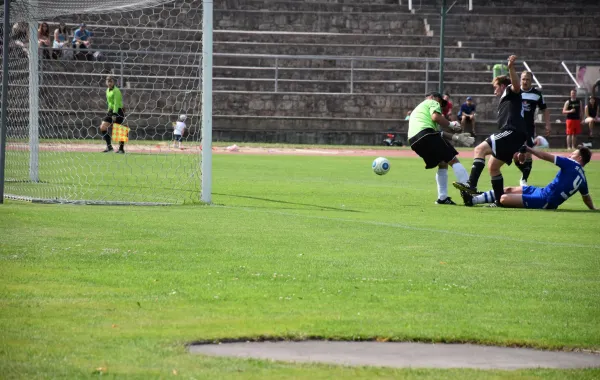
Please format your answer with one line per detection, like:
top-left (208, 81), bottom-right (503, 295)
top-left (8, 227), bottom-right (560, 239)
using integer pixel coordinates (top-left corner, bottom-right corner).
top-left (515, 71), bottom-right (550, 186)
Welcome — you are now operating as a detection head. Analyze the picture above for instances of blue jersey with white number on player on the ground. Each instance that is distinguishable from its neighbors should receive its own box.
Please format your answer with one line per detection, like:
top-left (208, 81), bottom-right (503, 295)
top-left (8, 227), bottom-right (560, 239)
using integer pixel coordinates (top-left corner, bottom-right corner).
top-left (543, 156), bottom-right (588, 208)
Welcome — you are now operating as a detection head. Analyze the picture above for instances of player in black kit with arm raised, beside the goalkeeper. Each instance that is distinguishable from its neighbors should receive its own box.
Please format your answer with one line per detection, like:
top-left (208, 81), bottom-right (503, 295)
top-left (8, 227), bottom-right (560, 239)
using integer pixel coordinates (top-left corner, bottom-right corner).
top-left (454, 55), bottom-right (527, 206)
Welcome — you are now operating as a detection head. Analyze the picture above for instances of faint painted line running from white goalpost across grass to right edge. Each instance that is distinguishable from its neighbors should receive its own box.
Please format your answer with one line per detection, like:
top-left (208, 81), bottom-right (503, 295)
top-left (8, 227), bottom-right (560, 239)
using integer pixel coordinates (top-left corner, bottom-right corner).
top-left (220, 205), bottom-right (600, 249)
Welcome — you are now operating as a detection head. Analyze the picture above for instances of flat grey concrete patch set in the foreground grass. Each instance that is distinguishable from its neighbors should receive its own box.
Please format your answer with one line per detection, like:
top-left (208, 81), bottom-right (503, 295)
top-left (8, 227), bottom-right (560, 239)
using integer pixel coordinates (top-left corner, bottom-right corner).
top-left (190, 341), bottom-right (600, 369)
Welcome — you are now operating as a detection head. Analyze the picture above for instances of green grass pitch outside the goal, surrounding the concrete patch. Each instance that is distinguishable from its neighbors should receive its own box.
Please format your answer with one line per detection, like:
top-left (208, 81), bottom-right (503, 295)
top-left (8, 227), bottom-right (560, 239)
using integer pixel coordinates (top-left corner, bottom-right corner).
top-left (0, 150), bottom-right (600, 379)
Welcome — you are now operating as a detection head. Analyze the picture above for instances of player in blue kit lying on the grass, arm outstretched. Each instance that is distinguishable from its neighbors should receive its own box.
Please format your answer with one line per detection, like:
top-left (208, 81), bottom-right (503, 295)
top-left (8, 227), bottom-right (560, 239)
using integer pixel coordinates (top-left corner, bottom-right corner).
top-left (461, 146), bottom-right (598, 210)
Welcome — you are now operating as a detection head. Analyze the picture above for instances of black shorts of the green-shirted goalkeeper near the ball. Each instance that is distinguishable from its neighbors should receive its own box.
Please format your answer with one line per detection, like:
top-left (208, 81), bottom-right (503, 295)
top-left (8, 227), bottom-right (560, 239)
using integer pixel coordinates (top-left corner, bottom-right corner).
top-left (408, 128), bottom-right (458, 169)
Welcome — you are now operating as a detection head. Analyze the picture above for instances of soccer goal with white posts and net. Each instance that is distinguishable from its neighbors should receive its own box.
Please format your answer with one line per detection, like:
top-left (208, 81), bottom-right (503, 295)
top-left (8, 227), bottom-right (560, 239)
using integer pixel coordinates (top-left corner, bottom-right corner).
top-left (0, 0), bottom-right (213, 204)
